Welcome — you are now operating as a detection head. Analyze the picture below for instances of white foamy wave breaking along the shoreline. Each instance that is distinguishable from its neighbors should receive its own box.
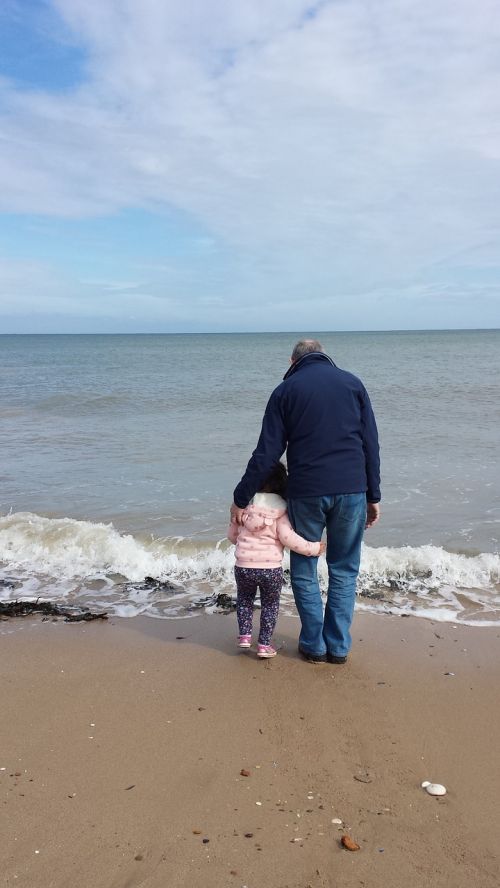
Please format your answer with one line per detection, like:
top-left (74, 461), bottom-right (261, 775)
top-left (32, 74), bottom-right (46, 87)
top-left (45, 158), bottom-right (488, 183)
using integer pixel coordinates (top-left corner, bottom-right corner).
top-left (0, 512), bottom-right (500, 625)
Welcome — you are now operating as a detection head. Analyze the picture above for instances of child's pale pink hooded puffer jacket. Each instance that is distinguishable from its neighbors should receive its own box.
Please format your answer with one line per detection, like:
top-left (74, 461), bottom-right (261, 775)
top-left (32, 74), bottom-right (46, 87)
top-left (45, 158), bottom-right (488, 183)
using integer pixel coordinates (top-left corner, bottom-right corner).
top-left (227, 493), bottom-right (320, 568)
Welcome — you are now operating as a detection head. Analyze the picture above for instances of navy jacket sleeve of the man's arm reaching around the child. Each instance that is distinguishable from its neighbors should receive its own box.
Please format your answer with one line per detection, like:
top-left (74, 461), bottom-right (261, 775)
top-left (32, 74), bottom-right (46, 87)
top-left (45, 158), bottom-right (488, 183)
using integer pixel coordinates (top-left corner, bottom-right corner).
top-left (233, 387), bottom-right (286, 509)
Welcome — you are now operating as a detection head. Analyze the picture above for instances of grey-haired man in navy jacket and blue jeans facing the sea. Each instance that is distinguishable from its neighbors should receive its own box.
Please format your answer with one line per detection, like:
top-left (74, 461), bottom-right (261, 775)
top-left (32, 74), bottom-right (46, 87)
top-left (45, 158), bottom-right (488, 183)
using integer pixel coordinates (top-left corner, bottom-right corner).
top-left (231, 339), bottom-right (380, 663)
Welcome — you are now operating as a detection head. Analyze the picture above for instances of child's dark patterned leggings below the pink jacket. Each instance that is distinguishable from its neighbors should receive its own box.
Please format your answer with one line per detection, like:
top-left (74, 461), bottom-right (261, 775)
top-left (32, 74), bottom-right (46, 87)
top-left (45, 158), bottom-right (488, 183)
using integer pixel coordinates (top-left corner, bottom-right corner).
top-left (234, 567), bottom-right (283, 644)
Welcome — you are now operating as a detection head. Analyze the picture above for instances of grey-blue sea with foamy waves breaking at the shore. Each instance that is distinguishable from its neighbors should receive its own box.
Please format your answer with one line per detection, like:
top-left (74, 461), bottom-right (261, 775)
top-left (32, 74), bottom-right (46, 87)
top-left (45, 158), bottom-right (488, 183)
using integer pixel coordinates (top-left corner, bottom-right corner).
top-left (0, 330), bottom-right (500, 625)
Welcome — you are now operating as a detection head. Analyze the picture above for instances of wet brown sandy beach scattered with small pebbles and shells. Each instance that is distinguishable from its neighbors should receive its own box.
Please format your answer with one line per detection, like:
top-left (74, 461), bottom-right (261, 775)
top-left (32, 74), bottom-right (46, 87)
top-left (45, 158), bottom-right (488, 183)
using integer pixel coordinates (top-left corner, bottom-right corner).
top-left (0, 614), bottom-right (500, 888)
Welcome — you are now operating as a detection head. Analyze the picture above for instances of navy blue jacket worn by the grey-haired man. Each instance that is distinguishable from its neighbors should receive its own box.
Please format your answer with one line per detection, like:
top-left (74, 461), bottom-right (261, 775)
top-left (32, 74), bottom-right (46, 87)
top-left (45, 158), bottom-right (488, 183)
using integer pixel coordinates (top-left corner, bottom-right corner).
top-left (234, 352), bottom-right (380, 508)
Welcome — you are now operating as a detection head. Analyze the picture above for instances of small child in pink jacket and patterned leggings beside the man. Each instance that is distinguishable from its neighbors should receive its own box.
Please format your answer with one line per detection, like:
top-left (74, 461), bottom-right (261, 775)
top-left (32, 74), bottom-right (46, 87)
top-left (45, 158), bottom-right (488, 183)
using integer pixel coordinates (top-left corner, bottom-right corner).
top-left (227, 462), bottom-right (326, 659)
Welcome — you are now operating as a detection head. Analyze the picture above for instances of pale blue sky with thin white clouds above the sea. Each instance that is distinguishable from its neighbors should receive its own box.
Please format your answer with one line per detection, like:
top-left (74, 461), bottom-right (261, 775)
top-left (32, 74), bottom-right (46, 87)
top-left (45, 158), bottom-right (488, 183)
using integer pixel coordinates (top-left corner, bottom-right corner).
top-left (0, 0), bottom-right (500, 333)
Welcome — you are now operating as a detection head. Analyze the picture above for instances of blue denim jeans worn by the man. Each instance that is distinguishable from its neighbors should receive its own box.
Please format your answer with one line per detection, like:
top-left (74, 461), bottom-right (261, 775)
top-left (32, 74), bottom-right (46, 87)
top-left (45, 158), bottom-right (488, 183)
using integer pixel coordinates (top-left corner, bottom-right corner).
top-left (287, 493), bottom-right (366, 657)
